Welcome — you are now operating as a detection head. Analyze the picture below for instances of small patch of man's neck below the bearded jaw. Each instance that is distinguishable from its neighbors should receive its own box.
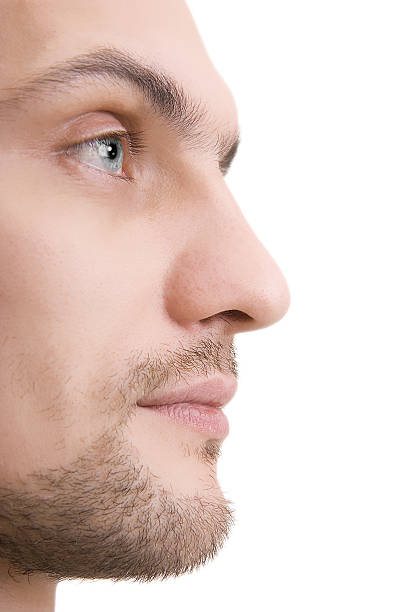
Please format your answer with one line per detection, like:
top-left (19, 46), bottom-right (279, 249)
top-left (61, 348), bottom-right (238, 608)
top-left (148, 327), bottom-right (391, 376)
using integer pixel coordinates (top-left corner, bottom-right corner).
top-left (0, 559), bottom-right (58, 612)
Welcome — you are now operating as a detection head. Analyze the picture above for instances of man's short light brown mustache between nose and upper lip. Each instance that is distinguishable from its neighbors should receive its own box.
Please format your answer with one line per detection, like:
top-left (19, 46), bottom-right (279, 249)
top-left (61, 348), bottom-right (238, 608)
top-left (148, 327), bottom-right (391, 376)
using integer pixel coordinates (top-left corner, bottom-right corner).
top-left (119, 338), bottom-right (238, 397)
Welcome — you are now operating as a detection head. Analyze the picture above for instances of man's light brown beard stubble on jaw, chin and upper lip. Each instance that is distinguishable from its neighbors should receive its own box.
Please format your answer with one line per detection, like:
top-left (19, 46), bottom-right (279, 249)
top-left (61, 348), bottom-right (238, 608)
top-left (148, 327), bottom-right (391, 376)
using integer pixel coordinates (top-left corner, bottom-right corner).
top-left (0, 341), bottom-right (236, 582)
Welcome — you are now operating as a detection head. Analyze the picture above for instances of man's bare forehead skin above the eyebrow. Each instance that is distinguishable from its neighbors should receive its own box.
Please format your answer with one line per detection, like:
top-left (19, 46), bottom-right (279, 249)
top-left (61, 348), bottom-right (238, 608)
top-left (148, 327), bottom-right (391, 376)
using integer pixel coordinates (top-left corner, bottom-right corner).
top-left (0, 0), bottom-right (237, 125)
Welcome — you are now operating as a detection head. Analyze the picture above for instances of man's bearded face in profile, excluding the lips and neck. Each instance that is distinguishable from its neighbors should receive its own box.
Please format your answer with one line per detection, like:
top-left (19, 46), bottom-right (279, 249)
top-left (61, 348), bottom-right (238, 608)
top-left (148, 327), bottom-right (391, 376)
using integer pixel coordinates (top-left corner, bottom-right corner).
top-left (0, 0), bottom-right (289, 580)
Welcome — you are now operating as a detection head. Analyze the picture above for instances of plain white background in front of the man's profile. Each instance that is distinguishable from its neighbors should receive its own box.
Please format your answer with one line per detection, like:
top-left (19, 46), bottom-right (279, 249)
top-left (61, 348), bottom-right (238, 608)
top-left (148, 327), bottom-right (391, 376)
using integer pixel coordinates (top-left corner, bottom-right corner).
top-left (56, 0), bottom-right (408, 612)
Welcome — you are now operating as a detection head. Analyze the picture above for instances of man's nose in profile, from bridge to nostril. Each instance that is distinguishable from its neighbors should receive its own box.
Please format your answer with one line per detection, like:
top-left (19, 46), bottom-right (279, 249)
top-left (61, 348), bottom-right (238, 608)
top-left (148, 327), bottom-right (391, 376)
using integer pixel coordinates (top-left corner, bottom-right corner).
top-left (165, 172), bottom-right (290, 333)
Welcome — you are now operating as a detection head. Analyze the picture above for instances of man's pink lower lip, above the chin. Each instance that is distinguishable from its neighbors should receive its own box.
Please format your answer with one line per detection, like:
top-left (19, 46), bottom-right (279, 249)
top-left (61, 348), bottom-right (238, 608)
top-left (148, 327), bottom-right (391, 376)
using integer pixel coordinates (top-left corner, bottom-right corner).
top-left (139, 403), bottom-right (229, 438)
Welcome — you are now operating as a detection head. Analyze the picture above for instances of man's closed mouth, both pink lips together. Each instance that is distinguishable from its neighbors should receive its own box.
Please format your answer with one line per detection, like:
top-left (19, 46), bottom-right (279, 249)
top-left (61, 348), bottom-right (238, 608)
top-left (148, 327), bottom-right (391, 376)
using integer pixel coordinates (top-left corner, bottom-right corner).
top-left (137, 376), bottom-right (238, 438)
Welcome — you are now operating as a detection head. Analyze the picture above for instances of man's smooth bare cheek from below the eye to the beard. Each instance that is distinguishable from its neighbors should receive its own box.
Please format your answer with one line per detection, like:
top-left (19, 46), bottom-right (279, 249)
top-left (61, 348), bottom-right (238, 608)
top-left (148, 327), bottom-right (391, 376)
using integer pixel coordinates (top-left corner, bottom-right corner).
top-left (0, 172), bottom-right (166, 482)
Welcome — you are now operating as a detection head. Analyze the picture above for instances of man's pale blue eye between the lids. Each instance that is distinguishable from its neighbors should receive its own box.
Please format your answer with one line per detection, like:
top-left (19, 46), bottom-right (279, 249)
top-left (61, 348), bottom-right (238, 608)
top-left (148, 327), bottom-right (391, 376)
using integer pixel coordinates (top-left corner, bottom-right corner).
top-left (71, 136), bottom-right (124, 174)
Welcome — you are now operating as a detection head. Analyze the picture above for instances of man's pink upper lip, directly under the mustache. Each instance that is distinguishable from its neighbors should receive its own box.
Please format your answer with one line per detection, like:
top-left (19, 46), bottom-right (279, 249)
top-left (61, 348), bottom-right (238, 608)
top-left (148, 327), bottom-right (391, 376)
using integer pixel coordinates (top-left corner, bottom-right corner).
top-left (137, 376), bottom-right (238, 408)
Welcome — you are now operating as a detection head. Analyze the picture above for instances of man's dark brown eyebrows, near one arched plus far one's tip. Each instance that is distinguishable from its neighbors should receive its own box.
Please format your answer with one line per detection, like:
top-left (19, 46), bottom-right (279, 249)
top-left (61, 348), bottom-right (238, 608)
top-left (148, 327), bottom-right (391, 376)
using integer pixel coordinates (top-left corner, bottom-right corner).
top-left (0, 46), bottom-right (240, 175)
